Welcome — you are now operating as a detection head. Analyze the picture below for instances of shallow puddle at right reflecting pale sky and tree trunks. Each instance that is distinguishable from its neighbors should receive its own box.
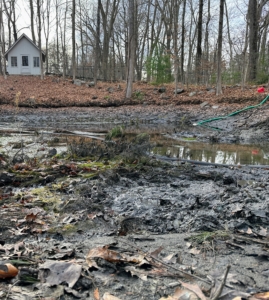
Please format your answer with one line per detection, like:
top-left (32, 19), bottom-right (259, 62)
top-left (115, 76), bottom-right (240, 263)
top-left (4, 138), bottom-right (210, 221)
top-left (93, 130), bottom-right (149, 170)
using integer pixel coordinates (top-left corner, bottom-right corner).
top-left (152, 141), bottom-right (269, 165)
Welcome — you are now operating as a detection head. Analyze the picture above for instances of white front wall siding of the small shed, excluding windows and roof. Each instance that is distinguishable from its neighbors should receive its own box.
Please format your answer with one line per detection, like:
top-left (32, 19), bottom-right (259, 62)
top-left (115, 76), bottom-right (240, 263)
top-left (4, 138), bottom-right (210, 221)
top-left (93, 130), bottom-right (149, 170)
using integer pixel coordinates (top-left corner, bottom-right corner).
top-left (7, 37), bottom-right (40, 75)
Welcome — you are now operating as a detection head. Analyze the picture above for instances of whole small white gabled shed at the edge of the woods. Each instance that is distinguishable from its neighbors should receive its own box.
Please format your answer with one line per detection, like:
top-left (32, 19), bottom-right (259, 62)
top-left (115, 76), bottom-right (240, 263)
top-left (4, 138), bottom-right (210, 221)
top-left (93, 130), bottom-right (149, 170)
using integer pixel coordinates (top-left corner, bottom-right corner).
top-left (5, 34), bottom-right (45, 75)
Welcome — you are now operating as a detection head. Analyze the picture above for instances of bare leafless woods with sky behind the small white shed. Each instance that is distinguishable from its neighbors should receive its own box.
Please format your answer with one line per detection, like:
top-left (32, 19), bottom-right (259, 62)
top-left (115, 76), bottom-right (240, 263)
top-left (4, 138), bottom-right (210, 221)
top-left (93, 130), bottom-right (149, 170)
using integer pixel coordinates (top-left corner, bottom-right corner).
top-left (0, 0), bottom-right (269, 89)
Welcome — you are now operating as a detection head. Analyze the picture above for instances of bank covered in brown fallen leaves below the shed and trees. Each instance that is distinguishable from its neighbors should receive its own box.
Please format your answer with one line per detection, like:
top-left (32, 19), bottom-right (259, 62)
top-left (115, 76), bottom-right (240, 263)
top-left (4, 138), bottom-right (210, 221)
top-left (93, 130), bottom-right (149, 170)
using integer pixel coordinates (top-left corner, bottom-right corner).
top-left (0, 76), bottom-right (263, 108)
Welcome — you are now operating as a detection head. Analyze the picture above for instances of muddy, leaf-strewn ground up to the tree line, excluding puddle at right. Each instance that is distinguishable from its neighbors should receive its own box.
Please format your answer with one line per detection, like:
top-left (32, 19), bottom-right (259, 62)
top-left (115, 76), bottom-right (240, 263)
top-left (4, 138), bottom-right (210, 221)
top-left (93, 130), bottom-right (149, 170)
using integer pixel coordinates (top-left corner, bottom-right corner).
top-left (0, 76), bottom-right (269, 300)
